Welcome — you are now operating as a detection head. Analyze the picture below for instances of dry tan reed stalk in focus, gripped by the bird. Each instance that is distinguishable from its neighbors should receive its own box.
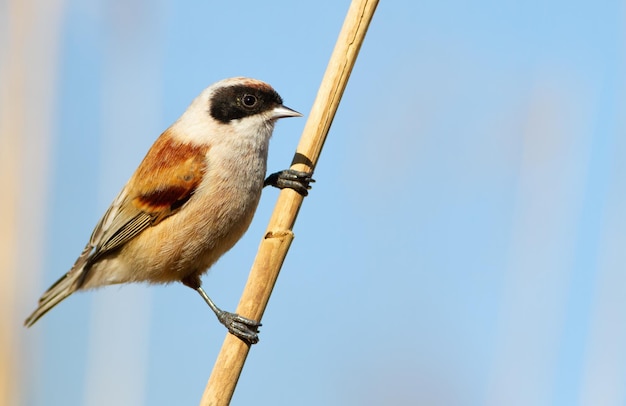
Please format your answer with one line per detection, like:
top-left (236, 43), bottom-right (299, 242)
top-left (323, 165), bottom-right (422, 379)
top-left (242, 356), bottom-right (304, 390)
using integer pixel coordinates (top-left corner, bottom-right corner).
top-left (200, 0), bottom-right (378, 406)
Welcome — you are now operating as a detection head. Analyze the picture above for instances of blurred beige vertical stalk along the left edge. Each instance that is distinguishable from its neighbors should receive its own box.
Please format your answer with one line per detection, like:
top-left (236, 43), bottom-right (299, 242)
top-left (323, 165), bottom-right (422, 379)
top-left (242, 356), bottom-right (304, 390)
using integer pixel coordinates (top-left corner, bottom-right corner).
top-left (0, 0), bottom-right (62, 406)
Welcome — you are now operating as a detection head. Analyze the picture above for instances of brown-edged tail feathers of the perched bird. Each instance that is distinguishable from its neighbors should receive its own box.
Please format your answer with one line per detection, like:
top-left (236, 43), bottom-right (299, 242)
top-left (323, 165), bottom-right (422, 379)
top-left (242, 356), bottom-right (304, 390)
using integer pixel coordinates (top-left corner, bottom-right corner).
top-left (24, 245), bottom-right (92, 327)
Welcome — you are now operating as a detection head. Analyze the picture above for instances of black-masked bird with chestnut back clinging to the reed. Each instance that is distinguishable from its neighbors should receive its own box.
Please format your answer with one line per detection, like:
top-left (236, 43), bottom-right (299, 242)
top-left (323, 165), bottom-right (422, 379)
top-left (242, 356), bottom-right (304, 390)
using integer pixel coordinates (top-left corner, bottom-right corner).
top-left (24, 77), bottom-right (314, 344)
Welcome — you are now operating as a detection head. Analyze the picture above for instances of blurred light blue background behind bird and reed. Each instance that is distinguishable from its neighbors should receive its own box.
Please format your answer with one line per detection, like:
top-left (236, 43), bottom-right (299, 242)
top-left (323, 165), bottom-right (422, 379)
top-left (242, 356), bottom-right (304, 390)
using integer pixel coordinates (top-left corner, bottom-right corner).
top-left (0, 0), bottom-right (626, 406)
